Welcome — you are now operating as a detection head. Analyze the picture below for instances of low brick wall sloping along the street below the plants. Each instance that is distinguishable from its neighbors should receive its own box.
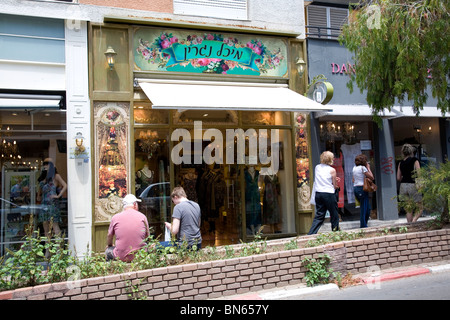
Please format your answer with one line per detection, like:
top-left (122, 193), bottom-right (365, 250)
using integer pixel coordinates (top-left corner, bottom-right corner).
top-left (0, 229), bottom-right (450, 300)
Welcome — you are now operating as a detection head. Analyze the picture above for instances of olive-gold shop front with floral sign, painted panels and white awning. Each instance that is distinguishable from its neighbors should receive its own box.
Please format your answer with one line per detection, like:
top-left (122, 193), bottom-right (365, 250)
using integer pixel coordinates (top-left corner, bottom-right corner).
top-left (90, 24), bottom-right (328, 251)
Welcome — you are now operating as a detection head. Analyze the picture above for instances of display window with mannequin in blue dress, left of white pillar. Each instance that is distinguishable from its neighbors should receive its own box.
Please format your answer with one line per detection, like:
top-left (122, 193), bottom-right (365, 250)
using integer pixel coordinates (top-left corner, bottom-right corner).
top-left (0, 109), bottom-right (70, 256)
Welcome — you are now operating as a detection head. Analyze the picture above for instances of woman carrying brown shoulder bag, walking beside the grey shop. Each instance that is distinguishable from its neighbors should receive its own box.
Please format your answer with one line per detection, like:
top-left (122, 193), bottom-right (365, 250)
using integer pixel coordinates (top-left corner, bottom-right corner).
top-left (353, 154), bottom-right (374, 228)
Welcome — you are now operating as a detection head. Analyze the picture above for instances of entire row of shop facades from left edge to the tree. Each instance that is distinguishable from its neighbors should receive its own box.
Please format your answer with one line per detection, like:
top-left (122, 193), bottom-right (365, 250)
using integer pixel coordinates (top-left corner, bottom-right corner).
top-left (0, 0), bottom-right (450, 257)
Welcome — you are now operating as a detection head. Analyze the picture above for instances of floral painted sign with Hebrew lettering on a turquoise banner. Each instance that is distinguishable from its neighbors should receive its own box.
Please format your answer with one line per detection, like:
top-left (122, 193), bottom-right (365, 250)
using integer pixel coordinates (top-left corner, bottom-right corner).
top-left (134, 28), bottom-right (287, 77)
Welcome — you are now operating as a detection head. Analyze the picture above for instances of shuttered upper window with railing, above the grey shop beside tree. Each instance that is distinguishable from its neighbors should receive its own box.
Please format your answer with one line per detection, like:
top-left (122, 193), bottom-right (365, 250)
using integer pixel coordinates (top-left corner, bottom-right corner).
top-left (306, 5), bottom-right (348, 39)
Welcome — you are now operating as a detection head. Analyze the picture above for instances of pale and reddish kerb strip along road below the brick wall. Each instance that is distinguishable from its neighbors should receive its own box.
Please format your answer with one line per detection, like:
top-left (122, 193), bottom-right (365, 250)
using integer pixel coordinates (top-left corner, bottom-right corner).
top-left (212, 260), bottom-right (450, 300)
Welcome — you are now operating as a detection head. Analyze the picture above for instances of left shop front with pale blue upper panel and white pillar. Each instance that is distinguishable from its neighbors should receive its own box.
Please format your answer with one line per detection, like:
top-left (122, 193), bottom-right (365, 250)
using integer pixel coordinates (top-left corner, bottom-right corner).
top-left (0, 14), bottom-right (91, 256)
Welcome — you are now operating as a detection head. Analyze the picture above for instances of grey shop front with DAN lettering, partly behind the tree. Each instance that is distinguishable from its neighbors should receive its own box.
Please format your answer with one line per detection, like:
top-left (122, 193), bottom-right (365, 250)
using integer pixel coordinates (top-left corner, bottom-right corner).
top-left (307, 39), bottom-right (449, 221)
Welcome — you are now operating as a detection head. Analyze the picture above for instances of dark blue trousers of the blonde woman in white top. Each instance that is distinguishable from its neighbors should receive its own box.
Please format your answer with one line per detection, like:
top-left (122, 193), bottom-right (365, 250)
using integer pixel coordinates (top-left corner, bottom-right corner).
top-left (308, 192), bottom-right (339, 234)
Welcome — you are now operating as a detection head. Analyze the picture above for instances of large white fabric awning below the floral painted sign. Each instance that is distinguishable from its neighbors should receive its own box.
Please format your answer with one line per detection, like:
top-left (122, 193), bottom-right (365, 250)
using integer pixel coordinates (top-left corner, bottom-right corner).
top-left (137, 79), bottom-right (331, 112)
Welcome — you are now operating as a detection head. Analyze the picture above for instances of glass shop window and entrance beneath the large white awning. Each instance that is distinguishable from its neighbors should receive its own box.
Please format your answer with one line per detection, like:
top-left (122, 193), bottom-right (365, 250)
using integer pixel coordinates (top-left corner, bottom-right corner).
top-left (134, 110), bottom-right (295, 246)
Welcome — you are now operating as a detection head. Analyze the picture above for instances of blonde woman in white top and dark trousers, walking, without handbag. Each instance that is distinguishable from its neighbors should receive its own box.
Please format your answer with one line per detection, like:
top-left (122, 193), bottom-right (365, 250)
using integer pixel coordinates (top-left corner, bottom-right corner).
top-left (308, 151), bottom-right (340, 234)
